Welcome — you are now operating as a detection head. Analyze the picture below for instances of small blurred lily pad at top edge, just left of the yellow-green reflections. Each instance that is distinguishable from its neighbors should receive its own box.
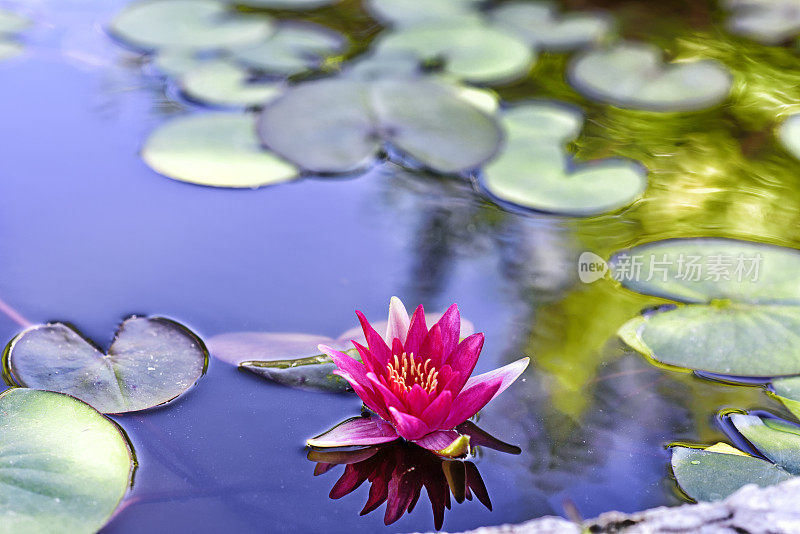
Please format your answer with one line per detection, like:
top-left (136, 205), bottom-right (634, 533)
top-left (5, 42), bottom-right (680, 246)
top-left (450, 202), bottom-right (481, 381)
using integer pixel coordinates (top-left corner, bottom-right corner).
top-left (490, 2), bottom-right (613, 51)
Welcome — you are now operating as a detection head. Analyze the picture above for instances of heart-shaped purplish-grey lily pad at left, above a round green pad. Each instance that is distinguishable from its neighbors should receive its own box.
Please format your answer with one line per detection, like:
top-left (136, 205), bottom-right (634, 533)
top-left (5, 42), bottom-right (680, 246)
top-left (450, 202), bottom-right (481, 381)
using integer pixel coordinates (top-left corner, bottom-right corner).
top-left (3, 317), bottom-right (208, 413)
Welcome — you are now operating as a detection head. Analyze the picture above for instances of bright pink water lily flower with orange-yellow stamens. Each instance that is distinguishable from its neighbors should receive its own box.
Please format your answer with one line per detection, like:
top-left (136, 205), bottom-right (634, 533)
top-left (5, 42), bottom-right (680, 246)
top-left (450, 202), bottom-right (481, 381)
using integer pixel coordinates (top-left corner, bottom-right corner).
top-left (308, 297), bottom-right (529, 456)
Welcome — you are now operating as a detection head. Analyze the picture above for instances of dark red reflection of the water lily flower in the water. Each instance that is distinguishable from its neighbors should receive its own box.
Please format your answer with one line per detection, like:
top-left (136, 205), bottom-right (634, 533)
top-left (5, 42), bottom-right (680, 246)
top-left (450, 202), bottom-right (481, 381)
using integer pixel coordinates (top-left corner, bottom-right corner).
top-left (308, 421), bottom-right (521, 530)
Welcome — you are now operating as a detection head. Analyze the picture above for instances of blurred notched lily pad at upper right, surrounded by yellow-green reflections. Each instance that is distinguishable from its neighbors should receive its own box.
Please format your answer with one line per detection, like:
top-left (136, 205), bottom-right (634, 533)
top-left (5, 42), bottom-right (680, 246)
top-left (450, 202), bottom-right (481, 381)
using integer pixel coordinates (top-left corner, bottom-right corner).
top-left (568, 42), bottom-right (732, 111)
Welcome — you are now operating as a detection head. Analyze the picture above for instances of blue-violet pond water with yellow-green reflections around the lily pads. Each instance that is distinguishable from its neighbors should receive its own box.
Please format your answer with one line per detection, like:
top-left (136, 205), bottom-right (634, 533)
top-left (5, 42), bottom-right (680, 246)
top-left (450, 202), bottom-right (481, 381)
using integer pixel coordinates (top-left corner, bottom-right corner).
top-left (0, 0), bottom-right (800, 533)
